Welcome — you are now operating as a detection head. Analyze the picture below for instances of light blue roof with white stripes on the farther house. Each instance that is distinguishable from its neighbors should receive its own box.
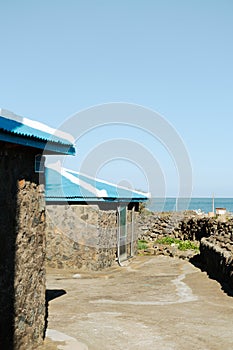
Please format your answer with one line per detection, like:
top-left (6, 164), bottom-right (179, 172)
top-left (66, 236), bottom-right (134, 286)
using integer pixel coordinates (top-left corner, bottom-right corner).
top-left (45, 166), bottom-right (148, 202)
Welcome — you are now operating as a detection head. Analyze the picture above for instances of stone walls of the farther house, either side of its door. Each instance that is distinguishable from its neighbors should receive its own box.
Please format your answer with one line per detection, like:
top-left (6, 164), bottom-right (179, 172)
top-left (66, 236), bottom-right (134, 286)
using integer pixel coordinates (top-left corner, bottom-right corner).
top-left (46, 204), bottom-right (138, 270)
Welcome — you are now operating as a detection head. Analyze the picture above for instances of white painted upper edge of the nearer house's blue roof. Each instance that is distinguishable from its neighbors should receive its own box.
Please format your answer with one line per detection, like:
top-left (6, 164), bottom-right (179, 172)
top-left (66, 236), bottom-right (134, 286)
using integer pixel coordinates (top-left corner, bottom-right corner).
top-left (0, 108), bottom-right (75, 144)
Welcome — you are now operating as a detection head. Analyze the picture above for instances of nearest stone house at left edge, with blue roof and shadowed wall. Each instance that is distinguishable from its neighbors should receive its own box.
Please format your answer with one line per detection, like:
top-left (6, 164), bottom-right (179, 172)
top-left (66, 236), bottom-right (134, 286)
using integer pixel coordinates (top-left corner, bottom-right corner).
top-left (0, 109), bottom-right (75, 350)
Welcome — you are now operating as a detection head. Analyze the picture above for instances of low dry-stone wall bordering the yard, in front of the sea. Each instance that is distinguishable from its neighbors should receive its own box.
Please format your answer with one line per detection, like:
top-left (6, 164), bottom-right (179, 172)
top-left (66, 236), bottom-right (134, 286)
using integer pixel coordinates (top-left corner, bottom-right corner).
top-left (139, 211), bottom-right (233, 288)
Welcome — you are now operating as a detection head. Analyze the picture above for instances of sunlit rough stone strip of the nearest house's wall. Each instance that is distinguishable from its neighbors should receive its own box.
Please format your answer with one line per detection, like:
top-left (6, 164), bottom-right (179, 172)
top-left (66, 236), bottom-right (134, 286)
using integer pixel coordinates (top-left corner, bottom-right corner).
top-left (15, 180), bottom-right (45, 349)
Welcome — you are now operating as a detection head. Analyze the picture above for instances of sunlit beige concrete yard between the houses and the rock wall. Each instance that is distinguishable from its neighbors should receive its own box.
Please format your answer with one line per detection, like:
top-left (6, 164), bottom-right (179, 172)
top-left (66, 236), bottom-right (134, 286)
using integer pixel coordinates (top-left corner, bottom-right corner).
top-left (41, 256), bottom-right (233, 350)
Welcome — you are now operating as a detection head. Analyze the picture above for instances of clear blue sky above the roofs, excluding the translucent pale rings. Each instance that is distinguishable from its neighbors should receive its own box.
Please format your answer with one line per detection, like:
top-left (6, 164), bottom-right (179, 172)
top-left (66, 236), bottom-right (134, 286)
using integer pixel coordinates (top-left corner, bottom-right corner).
top-left (0, 0), bottom-right (233, 197)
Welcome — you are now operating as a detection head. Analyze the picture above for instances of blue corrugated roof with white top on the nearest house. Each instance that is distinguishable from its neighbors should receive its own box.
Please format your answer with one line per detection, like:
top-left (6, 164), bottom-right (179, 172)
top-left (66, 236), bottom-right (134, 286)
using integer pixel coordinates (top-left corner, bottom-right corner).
top-left (0, 109), bottom-right (75, 154)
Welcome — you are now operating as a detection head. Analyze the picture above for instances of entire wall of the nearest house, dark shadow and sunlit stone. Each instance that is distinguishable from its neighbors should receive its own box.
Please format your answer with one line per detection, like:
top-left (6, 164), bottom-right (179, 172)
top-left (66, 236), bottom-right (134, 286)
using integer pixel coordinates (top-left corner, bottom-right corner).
top-left (0, 143), bottom-right (45, 350)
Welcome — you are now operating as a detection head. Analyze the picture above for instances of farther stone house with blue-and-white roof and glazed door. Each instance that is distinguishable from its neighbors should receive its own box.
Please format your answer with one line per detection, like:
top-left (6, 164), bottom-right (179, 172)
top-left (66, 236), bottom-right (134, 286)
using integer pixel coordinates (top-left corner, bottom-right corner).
top-left (45, 164), bottom-right (148, 270)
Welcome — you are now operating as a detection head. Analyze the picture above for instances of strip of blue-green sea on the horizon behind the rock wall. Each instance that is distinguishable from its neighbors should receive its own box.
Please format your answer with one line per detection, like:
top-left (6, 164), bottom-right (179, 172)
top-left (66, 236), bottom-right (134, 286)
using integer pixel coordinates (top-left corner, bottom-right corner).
top-left (146, 198), bottom-right (233, 213)
